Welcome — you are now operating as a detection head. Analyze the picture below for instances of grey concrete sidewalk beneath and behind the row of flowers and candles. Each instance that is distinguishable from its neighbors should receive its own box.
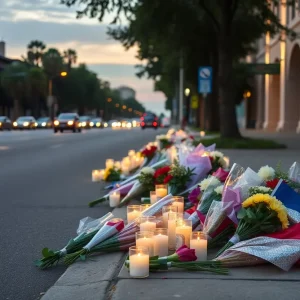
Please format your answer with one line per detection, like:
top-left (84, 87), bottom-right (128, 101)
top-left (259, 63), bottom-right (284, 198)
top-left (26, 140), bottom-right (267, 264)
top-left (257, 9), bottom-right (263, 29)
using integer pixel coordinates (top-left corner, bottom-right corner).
top-left (42, 140), bottom-right (300, 300)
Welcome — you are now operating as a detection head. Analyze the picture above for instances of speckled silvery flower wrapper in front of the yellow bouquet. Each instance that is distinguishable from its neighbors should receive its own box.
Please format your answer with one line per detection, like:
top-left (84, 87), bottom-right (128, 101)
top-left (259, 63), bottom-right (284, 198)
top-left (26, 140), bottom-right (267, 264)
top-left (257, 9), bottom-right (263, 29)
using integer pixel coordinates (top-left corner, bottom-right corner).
top-left (216, 236), bottom-right (300, 271)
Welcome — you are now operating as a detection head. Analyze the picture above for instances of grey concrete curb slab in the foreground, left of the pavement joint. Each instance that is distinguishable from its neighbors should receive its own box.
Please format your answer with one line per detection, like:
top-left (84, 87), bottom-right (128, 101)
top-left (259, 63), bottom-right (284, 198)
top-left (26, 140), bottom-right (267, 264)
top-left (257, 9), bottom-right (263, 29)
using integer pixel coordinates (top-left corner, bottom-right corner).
top-left (42, 207), bottom-right (127, 300)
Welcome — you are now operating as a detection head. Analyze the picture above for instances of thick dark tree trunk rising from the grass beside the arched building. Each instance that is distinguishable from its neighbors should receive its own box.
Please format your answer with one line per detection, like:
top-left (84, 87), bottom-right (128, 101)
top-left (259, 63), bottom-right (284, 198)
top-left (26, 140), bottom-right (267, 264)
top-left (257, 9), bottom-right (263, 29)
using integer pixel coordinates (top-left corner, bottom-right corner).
top-left (218, 1), bottom-right (241, 138)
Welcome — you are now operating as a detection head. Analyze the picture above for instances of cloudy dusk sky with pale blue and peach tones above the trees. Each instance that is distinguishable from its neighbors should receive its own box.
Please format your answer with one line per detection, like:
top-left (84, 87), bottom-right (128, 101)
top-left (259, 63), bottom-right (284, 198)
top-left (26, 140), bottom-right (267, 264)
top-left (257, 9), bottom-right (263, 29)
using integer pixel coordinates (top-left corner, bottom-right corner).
top-left (0, 0), bottom-right (165, 113)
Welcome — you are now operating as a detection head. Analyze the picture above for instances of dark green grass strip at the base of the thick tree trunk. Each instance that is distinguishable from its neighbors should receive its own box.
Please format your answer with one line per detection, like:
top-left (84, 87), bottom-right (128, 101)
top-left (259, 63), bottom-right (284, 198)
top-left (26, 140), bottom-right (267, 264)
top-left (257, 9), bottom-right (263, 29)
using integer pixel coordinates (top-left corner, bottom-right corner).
top-left (194, 137), bottom-right (286, 149)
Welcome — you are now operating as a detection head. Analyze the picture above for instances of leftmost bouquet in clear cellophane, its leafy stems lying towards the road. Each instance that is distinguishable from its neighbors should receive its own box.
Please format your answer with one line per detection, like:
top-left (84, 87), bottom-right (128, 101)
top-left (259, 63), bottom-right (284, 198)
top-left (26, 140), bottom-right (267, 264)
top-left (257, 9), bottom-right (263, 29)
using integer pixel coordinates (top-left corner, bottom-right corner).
top-left (35, 213), bottom-right (113, 270)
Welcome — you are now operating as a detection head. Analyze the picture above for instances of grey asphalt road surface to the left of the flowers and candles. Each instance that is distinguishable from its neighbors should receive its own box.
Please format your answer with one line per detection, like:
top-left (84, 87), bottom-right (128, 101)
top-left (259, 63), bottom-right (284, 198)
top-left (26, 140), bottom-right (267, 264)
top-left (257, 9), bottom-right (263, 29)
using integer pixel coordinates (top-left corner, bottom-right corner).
top-left (0, 129), bottom-right (161, 300)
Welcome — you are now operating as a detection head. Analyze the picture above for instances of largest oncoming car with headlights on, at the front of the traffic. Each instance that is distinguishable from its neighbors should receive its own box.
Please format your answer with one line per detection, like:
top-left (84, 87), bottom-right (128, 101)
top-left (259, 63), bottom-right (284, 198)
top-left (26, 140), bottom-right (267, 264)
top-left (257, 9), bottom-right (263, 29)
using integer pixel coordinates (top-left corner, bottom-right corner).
top-left (53, 113), bottom-right (81, 133)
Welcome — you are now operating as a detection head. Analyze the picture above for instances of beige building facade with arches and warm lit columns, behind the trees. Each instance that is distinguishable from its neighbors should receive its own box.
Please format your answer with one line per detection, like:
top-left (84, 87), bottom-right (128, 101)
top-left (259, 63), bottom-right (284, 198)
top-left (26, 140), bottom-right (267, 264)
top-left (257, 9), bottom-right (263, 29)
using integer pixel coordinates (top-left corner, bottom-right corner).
top-left (244, 1), bottom-right (300, 132)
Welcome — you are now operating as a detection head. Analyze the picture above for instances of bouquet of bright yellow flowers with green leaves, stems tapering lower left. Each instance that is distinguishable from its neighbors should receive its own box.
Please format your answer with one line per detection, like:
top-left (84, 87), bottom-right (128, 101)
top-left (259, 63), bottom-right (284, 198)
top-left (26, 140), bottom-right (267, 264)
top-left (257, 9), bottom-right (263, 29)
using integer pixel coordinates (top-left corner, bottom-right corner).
top-left (217, 194), bottom-right (289, 256)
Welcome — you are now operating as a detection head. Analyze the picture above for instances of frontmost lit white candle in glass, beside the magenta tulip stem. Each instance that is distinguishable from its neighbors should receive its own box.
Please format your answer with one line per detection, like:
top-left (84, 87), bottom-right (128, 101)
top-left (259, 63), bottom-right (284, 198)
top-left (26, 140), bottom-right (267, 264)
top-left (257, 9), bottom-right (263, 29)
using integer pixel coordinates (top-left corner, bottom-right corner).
top-left (129, 247), bottom-right (149, 278)
